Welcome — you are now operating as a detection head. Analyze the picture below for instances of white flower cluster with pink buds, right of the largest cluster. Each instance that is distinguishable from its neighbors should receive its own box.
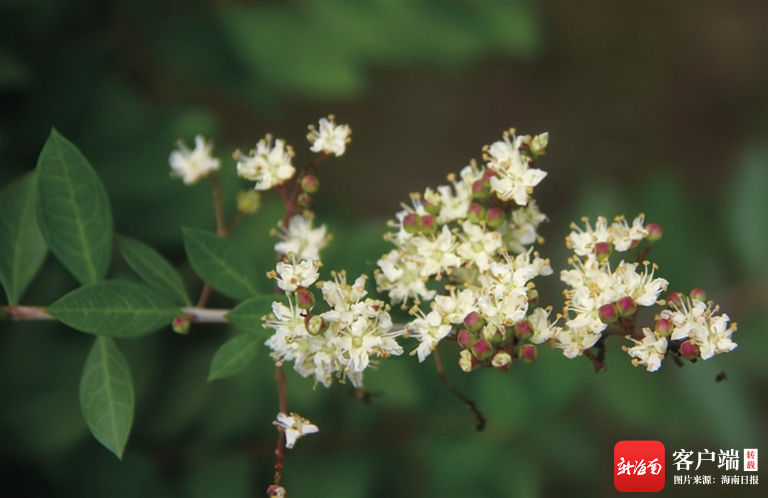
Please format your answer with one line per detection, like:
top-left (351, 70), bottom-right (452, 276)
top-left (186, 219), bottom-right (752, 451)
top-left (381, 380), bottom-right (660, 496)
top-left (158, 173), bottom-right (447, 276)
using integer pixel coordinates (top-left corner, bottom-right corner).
top-left (554, 214), bottom-right (667, 358)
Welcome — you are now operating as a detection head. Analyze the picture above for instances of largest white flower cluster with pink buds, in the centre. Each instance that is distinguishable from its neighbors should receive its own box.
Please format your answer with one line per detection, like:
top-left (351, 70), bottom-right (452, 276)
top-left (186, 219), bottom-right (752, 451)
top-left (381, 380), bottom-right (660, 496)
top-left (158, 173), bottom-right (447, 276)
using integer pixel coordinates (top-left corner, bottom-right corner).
top-left (376, 130), bottom-right (555, 371)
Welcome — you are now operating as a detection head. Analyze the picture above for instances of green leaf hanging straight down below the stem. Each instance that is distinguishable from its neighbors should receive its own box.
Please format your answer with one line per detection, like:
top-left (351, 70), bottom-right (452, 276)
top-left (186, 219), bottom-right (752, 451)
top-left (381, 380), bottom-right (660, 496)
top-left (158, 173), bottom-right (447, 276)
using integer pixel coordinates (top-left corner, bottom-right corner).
top-left (80, 337), bottom-right (134, 460)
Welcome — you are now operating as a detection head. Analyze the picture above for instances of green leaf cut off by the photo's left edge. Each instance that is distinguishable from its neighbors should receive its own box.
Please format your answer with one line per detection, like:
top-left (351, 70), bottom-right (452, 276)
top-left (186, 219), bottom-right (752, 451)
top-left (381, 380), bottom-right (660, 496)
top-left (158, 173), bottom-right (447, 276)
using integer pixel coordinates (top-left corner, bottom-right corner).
top-left (0, 172), bottom-right (48, 305)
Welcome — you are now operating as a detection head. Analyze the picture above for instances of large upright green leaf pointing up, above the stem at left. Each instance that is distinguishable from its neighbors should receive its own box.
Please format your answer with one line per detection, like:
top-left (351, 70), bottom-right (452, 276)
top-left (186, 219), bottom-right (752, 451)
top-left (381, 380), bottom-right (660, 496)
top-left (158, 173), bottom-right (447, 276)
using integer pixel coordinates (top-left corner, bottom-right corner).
top-left (37, 129), bottom-right (112, 284)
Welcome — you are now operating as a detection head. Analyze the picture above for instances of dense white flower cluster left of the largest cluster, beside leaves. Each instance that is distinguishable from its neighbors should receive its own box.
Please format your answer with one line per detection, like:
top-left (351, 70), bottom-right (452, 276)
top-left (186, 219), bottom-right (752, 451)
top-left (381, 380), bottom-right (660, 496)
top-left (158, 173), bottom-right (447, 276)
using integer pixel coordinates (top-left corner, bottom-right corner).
top-left (264, 258), bottom-right (403, 387)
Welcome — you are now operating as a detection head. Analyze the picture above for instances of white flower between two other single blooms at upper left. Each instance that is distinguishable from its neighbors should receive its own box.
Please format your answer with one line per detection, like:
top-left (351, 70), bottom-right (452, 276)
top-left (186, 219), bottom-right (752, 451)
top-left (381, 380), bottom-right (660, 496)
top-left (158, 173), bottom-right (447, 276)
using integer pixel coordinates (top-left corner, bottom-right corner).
top-left (237, 134), bottom-right (296, 190)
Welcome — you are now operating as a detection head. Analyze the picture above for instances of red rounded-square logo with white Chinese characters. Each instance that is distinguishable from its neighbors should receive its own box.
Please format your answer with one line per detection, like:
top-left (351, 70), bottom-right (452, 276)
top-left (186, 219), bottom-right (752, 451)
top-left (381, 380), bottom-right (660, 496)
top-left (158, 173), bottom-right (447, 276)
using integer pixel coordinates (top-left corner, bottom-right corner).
top-left (613, 441), bottom-right (665, 492)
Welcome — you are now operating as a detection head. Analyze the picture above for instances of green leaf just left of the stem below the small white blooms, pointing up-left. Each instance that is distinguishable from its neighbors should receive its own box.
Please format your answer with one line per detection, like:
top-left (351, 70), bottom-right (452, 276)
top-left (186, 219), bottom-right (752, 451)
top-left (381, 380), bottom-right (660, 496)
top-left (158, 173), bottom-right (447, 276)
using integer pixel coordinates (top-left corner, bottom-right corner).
top-left (183, 228), bottom-right (259, 299)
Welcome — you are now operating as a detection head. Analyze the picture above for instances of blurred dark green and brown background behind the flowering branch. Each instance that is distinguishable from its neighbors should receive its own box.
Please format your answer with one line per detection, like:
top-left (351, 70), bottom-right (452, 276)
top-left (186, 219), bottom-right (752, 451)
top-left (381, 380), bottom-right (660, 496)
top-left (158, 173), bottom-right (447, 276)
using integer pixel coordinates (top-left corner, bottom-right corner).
top-left (0, 0), bottom-right (768, 498)
